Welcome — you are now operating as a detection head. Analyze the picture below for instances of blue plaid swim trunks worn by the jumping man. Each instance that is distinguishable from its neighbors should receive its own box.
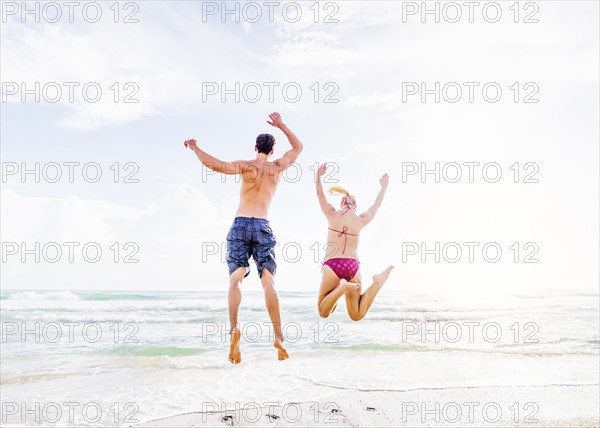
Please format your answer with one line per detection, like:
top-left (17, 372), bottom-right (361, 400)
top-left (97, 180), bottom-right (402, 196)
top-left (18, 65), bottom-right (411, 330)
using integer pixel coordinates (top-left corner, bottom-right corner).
top-left (227, 217), bottom-right (277, 277)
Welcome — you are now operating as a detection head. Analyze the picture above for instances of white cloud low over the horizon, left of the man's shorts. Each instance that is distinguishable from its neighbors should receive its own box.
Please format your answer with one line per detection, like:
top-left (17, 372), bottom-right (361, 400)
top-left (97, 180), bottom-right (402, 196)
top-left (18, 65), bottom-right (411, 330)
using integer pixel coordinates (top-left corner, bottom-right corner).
top-left (1, 184), bottom-right (230, 289)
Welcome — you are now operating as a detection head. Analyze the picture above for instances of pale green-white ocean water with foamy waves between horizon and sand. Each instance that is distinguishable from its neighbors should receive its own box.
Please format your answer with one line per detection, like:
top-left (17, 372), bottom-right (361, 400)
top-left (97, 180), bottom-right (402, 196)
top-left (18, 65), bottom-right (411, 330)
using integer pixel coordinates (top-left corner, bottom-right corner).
top-left (0, 291), bottom-right (600, 426)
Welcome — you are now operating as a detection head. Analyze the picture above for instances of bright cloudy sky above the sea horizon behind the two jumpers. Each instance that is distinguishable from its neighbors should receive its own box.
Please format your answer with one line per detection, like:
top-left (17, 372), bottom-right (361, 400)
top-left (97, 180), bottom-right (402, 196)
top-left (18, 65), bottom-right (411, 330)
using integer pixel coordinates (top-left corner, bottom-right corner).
top-left (0, 1), bottom-right (600, 294)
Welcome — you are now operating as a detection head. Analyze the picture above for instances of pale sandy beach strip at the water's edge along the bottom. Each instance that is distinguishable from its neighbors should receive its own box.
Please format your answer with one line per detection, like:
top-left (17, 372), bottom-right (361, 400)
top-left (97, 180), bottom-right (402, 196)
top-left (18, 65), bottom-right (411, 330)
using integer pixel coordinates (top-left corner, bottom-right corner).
top-left (132, 384), bottom-right (600, 428)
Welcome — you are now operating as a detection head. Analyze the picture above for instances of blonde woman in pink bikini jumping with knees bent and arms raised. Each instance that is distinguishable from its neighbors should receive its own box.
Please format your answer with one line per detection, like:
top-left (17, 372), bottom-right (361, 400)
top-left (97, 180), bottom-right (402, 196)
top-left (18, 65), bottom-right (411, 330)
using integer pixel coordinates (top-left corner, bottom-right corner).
top-left (316, 164), bottom-right (394, 321)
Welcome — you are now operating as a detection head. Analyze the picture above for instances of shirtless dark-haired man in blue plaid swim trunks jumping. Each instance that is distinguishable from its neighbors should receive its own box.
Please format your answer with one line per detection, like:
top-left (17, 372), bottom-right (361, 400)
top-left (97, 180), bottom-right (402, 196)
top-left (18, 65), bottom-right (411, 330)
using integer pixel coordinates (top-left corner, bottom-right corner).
top-left (184, 113), bottom-right (303, 364)
